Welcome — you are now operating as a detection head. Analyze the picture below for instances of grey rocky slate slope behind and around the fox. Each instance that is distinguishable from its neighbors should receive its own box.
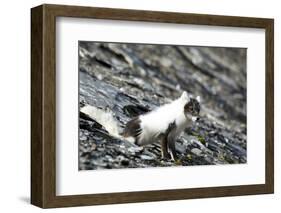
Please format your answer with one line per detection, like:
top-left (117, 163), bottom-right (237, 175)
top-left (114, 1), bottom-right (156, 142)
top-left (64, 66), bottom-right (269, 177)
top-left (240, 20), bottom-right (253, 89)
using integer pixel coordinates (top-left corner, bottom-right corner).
top-left (79, 42), bottom-right (247, 170)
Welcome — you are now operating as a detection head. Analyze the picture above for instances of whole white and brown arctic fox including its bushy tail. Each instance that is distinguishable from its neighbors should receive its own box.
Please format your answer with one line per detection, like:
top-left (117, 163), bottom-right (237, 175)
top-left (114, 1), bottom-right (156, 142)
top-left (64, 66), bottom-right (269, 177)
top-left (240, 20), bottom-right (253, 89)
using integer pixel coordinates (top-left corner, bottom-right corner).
top-left (80, 92), bottom-right (200, 159)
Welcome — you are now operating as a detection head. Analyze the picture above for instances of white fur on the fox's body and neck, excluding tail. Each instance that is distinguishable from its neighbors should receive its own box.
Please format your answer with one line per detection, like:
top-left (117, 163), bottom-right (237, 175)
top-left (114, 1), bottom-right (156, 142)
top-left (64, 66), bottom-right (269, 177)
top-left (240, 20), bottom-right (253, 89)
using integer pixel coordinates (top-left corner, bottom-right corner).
top-left (138, 92), bottom-right (191, 145)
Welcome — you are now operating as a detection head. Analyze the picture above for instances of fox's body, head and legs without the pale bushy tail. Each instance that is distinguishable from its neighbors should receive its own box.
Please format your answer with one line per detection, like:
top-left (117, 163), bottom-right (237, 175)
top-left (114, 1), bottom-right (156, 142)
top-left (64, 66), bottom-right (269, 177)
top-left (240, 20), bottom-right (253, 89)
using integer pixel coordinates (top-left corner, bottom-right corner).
top-left (123, 92), bottom-right (200, 158)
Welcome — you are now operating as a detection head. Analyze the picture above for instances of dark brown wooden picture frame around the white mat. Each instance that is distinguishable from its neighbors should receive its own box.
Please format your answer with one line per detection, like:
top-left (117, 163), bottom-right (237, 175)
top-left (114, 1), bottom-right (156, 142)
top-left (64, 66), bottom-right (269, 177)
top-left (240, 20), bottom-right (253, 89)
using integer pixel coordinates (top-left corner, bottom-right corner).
top-left (31, 5), bottom-right (274, 208)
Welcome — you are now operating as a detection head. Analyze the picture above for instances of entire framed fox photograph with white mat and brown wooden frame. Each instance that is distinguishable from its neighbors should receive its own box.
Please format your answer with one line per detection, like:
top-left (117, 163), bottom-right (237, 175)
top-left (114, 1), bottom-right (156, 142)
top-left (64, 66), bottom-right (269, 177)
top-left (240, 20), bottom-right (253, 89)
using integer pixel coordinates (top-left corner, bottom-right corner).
top-left (31, 5), bottom-right (274, 208)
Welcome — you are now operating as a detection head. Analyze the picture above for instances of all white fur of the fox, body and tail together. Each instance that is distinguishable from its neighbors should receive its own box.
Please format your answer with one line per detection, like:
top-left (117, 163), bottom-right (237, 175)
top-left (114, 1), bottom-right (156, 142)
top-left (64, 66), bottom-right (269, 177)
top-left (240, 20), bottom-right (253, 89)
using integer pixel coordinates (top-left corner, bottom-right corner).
top-left (80, 92), bottom-right (196, 145)
